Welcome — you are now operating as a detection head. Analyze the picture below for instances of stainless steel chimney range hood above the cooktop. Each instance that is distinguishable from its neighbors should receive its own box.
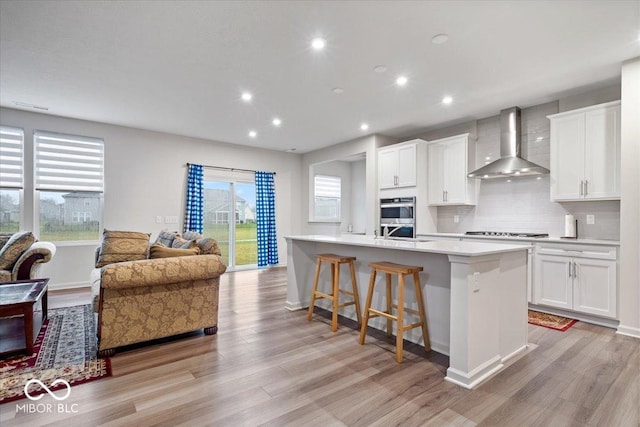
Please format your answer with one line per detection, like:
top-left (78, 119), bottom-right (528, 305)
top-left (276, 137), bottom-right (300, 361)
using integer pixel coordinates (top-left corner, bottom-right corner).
top-left (467, 107), bottom-right (549, 179)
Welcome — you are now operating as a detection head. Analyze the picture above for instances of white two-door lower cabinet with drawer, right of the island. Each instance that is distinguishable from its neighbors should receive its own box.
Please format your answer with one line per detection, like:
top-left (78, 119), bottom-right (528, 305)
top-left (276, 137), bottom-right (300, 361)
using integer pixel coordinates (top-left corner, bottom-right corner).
top-left (533, 244), bottom-right (618, 318)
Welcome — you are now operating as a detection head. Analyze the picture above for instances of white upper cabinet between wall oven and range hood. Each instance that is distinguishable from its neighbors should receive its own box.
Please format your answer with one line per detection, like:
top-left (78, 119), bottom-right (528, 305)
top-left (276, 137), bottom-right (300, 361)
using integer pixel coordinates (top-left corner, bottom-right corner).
top-left (427, 134), bottom-right (476, 206)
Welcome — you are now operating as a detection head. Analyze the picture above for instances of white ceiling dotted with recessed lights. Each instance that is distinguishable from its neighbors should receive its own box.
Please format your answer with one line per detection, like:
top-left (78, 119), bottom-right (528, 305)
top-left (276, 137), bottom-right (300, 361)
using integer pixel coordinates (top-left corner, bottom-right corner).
top-left (0, 0), bottom-right (640, 152)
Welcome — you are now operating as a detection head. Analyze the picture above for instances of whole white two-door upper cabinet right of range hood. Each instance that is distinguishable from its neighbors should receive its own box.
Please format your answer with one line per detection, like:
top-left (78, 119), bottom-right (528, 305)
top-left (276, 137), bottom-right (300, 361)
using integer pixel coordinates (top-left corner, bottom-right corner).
top-left (549, 101), bottom-right (620, 201)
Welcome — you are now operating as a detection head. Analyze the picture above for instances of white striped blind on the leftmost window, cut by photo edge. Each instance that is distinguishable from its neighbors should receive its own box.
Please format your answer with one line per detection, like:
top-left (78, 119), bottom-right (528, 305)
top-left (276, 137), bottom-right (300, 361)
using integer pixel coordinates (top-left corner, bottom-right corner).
top-left (0, 126), bottom-right (24, 189)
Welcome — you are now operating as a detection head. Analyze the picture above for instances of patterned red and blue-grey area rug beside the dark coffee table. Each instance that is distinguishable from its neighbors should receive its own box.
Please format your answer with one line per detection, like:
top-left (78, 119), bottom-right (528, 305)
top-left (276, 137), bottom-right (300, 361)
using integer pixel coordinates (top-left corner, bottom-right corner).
top-left (0, 305), bottom-right (111, 404)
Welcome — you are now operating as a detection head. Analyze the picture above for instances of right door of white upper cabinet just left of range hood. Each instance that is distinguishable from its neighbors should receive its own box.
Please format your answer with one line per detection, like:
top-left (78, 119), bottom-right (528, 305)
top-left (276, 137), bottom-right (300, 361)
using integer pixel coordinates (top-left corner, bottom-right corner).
top-left (443, 138), bottom-right (469, 204)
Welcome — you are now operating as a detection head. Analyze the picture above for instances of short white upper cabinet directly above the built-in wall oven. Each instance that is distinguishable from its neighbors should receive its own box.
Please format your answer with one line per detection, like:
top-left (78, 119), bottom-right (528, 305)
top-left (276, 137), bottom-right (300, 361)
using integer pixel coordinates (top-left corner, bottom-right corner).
top-left (378, 143), bottom-right (417, 189)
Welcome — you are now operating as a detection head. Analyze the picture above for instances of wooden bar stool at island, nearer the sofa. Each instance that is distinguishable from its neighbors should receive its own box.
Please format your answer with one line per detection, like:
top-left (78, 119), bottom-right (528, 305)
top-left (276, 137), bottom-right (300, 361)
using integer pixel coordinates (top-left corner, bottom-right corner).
top-left (307, 254), bottom-right (362, 332)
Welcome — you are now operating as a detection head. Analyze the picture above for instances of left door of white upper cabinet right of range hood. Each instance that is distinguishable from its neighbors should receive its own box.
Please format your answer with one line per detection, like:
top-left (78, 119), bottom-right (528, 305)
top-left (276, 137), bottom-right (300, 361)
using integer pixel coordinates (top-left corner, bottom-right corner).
top-left (551, 113), bottom-right (585, 200)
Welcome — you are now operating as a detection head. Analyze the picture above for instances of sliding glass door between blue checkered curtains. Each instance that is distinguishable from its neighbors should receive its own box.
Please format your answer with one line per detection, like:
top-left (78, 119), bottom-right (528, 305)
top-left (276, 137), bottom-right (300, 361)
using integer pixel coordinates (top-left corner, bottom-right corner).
top-left (204, 177), bottom-right (258, 267)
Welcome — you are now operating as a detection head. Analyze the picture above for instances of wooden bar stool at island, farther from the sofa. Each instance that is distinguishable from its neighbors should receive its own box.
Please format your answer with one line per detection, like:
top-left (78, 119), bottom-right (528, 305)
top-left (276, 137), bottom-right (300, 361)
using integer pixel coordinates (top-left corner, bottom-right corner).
top-left (360, 261), bottom-right (431, 363)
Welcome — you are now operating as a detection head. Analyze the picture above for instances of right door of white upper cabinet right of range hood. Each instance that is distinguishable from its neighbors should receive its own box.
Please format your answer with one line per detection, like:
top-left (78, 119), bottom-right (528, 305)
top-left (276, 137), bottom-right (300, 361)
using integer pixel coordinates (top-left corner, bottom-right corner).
top-left (584, 105), bottom-right (620, 199)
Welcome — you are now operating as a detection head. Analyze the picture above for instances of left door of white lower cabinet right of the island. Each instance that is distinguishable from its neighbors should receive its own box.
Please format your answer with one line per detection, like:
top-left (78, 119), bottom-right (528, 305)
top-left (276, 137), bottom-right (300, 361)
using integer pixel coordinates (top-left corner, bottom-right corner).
top-left (533, 255), bottom-right (573, 310)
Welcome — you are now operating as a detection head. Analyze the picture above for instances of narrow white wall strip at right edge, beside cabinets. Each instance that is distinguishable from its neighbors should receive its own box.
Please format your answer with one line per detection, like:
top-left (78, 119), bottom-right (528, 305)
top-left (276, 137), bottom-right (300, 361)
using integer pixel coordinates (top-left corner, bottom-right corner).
top-left (618, 57), bottom-right (640, 338)
